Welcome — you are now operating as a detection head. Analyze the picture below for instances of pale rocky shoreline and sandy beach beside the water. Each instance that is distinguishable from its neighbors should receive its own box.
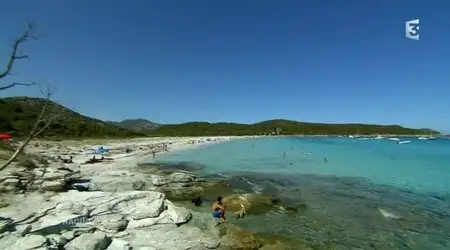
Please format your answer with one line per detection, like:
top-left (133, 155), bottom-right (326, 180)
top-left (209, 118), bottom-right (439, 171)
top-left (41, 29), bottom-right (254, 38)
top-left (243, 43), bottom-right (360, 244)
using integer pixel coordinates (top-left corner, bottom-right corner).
top-left (0, 138), bottom-right (304, 250)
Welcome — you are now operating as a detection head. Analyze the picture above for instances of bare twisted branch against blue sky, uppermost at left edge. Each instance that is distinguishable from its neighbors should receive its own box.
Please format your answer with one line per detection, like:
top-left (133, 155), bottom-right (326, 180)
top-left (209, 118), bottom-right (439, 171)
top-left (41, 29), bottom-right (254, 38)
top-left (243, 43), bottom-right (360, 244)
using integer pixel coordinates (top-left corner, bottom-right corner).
top-left (0, 22), bottom-right (36, 91)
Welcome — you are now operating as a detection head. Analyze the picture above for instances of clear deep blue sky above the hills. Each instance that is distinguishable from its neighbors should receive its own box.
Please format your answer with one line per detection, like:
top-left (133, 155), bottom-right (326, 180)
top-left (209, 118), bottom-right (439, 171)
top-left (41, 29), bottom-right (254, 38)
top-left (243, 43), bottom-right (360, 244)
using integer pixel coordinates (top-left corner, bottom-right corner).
top-left (0, 0), bottom-right (450, 131)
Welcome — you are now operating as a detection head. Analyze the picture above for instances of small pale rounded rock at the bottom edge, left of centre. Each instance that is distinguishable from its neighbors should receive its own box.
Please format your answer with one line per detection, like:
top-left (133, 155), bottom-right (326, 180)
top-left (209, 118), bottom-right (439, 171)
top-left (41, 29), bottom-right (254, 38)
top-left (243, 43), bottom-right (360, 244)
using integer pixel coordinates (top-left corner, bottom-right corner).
top-left (64, 232), bottom-right (111, 250)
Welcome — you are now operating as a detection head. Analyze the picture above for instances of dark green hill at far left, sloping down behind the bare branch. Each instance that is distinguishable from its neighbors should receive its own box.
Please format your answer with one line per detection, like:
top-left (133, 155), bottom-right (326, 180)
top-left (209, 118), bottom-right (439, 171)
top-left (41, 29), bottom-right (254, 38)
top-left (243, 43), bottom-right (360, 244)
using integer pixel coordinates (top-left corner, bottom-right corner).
top-left (0, 97), bottom-right (145, 138)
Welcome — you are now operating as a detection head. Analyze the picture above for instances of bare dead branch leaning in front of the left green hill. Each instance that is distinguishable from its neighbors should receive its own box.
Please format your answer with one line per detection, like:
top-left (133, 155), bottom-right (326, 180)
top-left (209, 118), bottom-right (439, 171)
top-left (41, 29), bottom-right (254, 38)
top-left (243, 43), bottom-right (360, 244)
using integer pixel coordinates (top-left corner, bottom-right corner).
top-left (0, 85), bottom-right (60, 171)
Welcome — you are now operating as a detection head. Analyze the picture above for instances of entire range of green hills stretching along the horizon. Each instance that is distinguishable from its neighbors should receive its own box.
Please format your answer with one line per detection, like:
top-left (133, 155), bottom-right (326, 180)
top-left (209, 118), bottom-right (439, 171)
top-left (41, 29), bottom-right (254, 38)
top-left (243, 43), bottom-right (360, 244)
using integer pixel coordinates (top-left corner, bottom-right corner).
top-left (0, 97), bottom-right (438, 138)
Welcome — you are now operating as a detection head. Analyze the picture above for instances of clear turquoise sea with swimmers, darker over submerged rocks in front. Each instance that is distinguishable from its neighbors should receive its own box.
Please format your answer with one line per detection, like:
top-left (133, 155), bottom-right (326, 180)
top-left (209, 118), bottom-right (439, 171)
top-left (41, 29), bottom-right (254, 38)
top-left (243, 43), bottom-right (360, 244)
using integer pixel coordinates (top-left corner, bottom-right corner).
top-left (152, 136), bottom-right (450, 250)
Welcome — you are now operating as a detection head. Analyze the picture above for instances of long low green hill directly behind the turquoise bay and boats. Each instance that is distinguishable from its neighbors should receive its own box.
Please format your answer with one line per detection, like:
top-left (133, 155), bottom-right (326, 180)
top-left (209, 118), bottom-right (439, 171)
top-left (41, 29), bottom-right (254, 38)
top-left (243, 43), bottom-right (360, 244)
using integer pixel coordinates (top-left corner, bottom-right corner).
top-left (148, 120), bottom-right (437, 136)
